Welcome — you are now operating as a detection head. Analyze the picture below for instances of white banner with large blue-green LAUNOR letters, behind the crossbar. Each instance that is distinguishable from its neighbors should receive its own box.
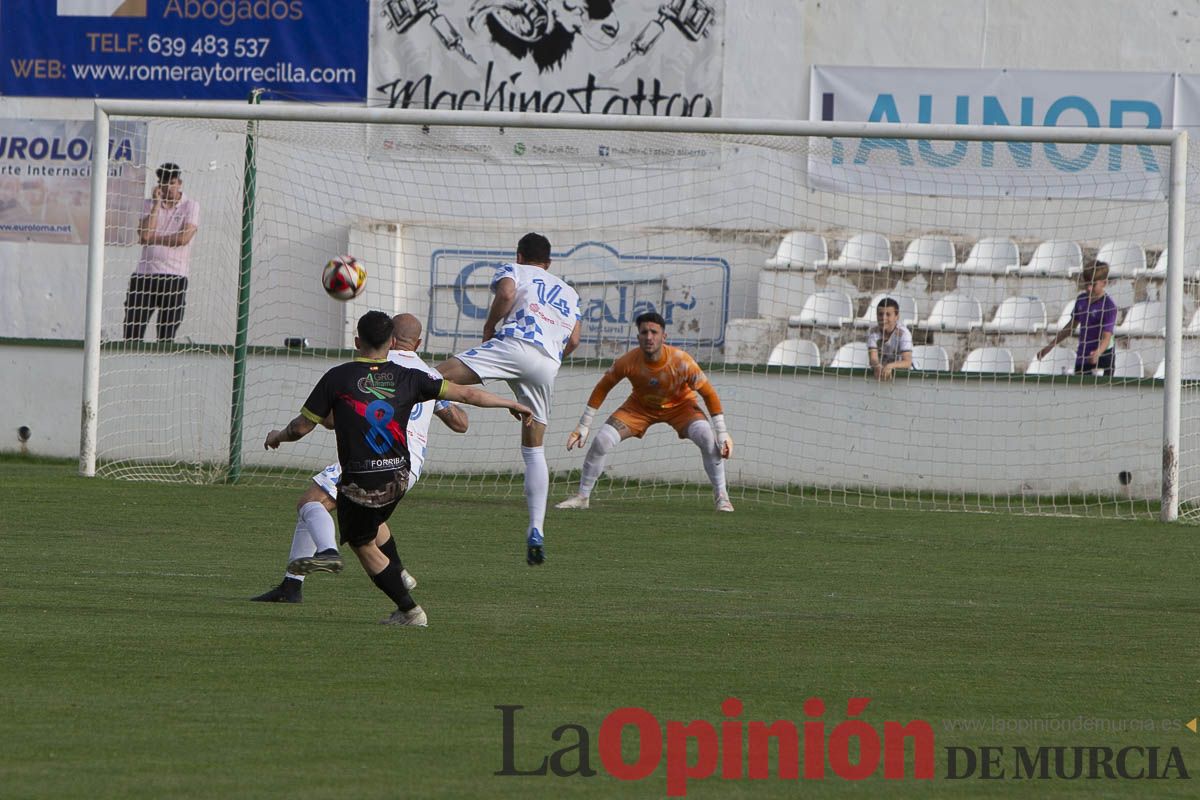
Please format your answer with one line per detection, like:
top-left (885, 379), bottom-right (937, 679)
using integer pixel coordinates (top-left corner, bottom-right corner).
top-left (809, 66), bottom-right (1174, 200)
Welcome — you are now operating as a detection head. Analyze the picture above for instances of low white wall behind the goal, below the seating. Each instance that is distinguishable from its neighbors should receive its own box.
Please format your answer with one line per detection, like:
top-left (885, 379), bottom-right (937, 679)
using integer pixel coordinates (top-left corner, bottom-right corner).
top-left (7, 347), bottom-right (1200, 498)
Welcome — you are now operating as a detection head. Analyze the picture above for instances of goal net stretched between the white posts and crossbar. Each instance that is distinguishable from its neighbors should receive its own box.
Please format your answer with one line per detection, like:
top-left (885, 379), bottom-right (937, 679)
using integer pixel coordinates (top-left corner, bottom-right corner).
top-left (83, 103), bottom-right (1200, 517)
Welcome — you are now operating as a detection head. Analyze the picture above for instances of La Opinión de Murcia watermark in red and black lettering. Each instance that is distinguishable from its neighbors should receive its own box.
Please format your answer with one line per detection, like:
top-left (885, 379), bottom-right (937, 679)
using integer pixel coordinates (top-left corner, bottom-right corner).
top-left (494, 697), bottom-right (1190, 798)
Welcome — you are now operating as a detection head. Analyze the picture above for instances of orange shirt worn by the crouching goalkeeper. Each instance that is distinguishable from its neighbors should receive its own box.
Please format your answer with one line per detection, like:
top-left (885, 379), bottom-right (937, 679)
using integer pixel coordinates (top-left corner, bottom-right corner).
top-left (588, 344), bottom-right (722, 414)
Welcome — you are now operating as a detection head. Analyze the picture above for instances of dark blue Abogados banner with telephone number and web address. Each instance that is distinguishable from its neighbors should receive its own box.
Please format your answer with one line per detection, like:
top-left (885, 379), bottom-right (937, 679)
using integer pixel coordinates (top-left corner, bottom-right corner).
top-left (0, 0), bottom-right (370, 101)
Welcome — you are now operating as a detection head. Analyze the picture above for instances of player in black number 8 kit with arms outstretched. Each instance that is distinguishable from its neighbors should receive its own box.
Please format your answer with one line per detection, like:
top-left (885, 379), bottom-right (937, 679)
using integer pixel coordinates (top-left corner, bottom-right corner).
top-left (264, 311), bottom-right (533, 627)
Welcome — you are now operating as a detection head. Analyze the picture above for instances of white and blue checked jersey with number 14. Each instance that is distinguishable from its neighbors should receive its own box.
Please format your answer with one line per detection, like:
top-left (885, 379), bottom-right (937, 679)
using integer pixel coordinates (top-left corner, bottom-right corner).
top-left (491, 264), bottom-right (582, 363)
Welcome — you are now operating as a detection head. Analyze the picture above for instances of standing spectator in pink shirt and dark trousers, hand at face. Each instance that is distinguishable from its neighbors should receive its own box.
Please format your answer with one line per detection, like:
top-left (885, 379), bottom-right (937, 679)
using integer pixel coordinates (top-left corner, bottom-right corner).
top-left (125, 162), bottom-right (200, 342)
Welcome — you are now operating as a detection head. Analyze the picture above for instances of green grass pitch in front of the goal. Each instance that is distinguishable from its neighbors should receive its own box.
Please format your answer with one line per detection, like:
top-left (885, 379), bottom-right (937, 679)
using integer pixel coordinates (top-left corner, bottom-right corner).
top-left (0, 457), bottom-right (1200, 799)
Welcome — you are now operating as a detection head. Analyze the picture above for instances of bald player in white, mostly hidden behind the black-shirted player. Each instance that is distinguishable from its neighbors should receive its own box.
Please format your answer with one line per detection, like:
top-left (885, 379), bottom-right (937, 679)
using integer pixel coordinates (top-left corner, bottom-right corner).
top-left (251, 314), bottom-right (467, 603)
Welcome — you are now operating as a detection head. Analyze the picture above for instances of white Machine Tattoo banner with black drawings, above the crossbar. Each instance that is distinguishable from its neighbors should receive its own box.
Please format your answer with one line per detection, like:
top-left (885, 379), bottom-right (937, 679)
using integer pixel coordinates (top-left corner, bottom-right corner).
top-left (367, 0), bottom-right (725, 116)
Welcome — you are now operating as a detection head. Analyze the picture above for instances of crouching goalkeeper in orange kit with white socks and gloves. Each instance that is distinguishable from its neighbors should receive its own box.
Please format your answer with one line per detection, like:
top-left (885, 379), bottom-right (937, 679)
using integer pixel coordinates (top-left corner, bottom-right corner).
top-left (554, 312), bottom-right (733, 511)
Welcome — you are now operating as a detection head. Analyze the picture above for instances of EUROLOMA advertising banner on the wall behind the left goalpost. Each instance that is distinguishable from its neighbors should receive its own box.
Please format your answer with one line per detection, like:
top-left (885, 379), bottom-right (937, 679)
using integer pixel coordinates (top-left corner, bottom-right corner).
top-left (0, 120), bottom-right (146, 245)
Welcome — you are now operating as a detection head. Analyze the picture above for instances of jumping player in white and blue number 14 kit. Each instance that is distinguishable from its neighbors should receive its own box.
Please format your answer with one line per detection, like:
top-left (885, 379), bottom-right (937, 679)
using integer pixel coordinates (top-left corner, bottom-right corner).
top-left (438, 233), bottom-right (582, 566)
